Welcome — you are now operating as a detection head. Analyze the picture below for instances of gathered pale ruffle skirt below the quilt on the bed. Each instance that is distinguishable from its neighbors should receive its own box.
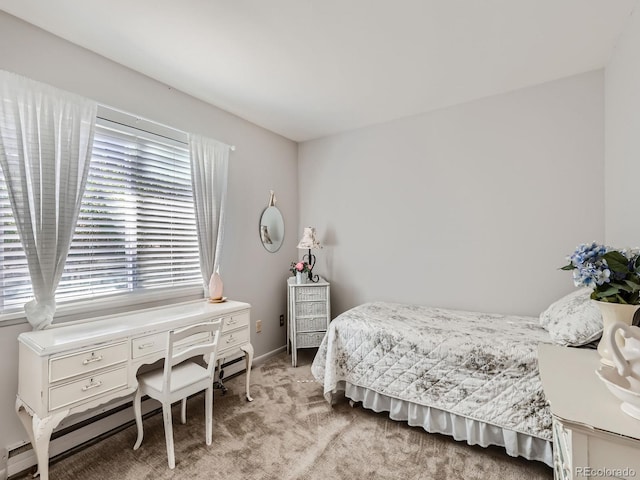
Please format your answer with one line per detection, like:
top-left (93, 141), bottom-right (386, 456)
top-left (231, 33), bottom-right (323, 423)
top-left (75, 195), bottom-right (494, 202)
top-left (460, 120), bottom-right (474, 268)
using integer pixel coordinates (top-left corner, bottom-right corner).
top-left (336, 381), bottom-right (553, 467)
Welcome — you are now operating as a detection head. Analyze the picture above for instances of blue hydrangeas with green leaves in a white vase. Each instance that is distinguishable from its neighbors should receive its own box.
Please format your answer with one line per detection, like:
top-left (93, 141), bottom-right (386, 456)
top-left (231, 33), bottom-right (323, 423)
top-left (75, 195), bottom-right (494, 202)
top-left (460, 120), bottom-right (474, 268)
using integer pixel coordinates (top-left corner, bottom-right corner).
top-left (562, 242), bottom-right (640, 366)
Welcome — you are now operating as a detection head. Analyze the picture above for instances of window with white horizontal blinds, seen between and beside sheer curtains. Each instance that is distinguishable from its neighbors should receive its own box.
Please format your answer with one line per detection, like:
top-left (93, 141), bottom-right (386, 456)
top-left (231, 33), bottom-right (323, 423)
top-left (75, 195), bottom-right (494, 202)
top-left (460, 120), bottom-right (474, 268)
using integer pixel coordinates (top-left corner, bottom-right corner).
top-left (0, 109), bottom-right (202, 313)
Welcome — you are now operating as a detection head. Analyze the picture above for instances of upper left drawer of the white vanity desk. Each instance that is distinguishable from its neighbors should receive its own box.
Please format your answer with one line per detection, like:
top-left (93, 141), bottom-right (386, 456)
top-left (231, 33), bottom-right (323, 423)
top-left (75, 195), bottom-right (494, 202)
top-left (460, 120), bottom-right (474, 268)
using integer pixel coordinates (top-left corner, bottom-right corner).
top-left (49, 342), bottom-right (129, 383)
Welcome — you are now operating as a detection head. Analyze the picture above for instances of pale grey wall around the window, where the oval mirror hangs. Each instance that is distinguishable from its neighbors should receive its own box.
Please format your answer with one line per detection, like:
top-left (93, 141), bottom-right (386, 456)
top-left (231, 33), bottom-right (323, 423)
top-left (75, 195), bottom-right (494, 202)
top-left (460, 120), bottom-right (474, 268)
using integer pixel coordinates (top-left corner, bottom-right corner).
top-left (0, 12), bottom-right (298, 454)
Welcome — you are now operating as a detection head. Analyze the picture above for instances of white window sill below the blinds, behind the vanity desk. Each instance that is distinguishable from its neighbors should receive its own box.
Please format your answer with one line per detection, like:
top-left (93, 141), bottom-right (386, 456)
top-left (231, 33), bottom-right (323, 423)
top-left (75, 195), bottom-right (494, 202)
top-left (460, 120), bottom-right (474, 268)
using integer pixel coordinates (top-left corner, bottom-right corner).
top-left (0, 286), bottom-right (204, 327)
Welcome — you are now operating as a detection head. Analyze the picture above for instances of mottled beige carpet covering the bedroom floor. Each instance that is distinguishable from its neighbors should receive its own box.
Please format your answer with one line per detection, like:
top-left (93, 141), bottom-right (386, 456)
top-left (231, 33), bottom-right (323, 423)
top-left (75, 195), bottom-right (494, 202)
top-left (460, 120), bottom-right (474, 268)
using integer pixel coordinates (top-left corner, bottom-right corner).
top-left (12, 351), bottom-right (553, 480)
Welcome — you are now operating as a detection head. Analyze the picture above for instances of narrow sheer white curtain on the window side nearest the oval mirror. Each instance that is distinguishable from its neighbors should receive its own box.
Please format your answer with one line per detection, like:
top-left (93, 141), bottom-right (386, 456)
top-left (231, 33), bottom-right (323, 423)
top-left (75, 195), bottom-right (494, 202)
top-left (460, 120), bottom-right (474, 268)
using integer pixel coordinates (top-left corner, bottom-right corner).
top-left (189, 134), bottom-right (231, 297)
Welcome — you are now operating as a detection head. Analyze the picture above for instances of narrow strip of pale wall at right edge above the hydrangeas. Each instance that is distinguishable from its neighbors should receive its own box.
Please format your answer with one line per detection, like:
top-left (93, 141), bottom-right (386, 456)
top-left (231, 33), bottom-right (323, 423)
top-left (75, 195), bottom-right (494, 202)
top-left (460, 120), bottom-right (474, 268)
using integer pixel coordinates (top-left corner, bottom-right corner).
top-left (605, 7), bottom-right (640, 247)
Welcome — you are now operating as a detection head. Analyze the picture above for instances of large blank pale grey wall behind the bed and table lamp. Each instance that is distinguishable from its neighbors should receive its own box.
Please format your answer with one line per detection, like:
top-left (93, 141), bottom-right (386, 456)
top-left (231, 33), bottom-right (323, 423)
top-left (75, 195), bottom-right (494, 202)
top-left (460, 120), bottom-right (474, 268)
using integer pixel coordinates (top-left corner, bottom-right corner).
top-left (298, 71), bottom-right (604, 315)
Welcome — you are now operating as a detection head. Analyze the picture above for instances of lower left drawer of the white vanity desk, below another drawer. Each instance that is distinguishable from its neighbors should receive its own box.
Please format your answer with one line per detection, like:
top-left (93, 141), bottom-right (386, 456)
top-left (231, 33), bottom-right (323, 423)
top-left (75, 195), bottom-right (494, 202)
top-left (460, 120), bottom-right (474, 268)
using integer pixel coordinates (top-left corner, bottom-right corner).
top-left (49, 366), bottom-right (127, 410)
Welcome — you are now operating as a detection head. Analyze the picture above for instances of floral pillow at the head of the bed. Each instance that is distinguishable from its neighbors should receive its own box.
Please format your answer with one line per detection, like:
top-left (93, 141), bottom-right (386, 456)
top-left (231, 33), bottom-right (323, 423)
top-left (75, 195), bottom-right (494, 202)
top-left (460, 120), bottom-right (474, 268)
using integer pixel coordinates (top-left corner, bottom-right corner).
top-left (540, 288), bottom-right (602, 347)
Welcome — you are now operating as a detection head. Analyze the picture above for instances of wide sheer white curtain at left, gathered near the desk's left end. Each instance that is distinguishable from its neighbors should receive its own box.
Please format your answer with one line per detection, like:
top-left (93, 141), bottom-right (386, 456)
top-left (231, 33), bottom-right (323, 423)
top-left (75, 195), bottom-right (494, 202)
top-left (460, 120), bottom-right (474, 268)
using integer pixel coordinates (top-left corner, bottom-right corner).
top-left (0, 71), bottom-right (97, 330)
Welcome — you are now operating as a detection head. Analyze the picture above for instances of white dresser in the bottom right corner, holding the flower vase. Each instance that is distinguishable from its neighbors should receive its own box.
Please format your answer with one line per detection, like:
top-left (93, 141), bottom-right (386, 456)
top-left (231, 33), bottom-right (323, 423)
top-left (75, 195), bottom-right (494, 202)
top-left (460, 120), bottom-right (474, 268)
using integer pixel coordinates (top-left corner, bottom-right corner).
top-left (538, 345), bottom-right (640, 480)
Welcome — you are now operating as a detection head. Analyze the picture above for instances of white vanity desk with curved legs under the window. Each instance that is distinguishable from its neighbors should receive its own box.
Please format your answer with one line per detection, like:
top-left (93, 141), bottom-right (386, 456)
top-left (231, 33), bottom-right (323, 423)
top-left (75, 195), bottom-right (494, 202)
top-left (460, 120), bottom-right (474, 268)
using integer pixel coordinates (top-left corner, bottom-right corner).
top-left (16, 299), bottom-right (253, 480)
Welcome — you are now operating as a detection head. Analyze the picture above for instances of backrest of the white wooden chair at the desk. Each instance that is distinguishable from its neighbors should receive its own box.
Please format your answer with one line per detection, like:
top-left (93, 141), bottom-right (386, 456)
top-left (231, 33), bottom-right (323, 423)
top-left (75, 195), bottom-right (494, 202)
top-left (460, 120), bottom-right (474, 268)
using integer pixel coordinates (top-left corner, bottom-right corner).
top-left (162, 318), bottom-right (224, 391)
